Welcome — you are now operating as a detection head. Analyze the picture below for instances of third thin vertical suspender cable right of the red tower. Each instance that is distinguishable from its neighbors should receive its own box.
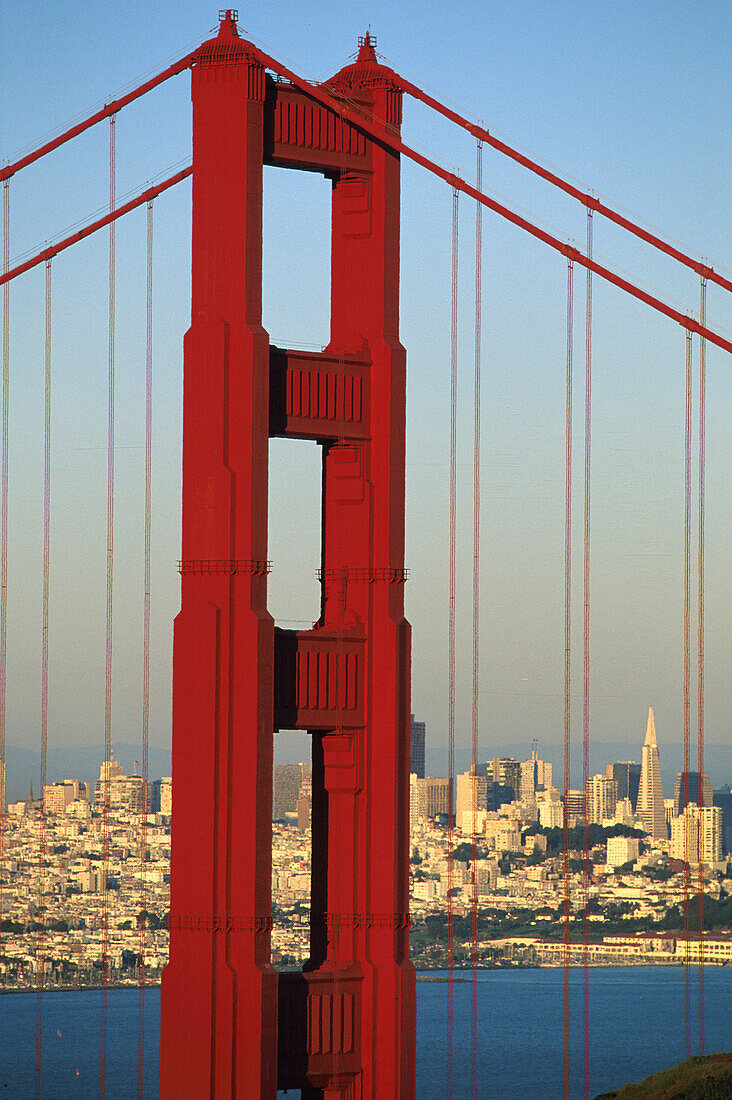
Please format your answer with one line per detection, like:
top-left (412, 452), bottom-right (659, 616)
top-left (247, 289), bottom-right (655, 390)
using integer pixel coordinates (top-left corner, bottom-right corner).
top-left (564, 260), bottom-right (575, 1100)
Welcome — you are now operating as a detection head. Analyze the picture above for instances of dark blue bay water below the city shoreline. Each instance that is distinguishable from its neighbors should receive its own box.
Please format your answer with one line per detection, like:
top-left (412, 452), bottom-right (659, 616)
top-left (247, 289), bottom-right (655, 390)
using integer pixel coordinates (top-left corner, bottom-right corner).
top-left (0, 967), bottom-right (732, 1100)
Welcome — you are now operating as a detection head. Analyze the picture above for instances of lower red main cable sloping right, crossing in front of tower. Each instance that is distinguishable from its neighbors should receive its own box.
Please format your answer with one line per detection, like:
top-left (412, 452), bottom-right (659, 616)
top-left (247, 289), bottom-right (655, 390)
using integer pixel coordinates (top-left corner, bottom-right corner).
top-left (250, 43), bottom-right (732, 354)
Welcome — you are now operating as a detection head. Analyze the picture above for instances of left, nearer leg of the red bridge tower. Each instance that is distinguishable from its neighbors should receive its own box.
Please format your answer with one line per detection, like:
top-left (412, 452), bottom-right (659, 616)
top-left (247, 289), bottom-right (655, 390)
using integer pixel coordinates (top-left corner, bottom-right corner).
top-left (161, 15), bottom-right (277, 1100)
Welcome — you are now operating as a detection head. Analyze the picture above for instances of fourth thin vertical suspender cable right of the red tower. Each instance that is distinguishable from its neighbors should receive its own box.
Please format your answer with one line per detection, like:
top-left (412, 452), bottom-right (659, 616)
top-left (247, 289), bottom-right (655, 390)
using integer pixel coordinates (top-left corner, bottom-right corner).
top-left (582, 210), bottom-right (592, 1100)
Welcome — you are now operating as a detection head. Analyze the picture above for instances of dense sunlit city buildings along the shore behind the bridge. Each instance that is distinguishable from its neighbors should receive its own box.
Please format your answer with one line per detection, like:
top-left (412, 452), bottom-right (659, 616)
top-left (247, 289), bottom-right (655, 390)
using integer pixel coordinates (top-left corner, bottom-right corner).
top-left (0, 711), bottom-right (732, 989)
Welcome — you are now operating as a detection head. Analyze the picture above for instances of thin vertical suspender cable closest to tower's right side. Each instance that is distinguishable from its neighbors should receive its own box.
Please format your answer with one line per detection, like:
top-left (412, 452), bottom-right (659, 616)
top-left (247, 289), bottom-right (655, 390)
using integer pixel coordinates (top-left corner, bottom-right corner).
top-left (446, 188), bottom-right (459, 1100)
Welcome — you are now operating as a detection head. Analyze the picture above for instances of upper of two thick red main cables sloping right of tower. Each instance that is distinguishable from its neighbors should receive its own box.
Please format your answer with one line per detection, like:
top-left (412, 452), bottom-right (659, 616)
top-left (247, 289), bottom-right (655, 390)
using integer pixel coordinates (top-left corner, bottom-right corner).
top-left (394, 73), bottom-right (732, 290)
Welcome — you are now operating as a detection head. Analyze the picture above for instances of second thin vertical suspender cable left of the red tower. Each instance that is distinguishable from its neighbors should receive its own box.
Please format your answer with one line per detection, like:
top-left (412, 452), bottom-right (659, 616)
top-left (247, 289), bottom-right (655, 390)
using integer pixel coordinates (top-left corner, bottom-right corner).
top-left (99, 114), bottom-right (117, 1100)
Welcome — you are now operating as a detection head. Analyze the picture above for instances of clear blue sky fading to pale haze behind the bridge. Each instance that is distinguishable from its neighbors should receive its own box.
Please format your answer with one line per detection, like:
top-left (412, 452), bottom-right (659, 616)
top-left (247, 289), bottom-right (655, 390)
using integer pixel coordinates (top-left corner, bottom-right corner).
top-left (0, 0), bottom-right (732, 781)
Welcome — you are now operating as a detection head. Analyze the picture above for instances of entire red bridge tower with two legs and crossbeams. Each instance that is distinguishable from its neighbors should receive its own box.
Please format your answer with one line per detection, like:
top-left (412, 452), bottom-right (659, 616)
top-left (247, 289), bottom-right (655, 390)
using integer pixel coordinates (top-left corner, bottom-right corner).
top-left (161, 13), bottom-right (415, 1100)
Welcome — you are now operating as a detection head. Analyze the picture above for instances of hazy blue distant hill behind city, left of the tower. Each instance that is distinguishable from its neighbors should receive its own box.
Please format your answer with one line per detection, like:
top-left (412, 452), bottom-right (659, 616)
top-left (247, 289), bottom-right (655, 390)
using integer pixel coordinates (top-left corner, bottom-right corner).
top-left (6, 743), bottom-right (171, 802)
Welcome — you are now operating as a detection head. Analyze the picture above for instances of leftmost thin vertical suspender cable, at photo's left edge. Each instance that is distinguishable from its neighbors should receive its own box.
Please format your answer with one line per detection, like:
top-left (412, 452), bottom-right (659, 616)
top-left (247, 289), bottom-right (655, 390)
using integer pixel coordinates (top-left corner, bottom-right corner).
top-left (0, 179), bottom-right (10, 959)
